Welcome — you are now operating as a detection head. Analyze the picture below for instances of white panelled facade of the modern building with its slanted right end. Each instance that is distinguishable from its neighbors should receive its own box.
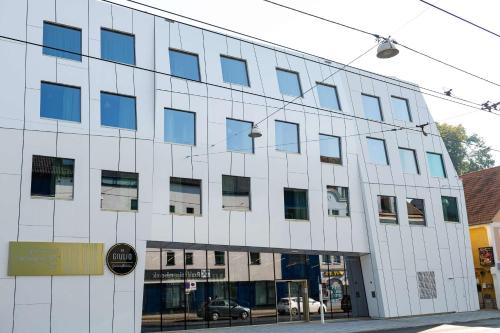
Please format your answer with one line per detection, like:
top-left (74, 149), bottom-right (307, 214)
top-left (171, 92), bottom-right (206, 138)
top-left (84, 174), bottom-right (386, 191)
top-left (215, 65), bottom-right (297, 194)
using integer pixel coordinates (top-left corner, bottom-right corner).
top-left (0, 0), bottom-right (479, 333)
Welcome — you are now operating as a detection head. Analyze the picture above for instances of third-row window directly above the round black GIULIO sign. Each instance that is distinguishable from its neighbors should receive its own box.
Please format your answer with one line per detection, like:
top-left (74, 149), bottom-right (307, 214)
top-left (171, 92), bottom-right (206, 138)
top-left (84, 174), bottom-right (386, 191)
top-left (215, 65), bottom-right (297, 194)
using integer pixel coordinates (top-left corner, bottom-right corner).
top-left (101, 170), bottom-right (139, 211)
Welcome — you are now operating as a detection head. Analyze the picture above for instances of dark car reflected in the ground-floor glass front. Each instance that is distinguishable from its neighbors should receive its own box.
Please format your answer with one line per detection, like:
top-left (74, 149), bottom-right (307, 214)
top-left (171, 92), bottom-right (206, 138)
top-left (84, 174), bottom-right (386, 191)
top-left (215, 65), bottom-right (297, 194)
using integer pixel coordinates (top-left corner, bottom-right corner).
top-left (196, 298), bottom-right (250, 320)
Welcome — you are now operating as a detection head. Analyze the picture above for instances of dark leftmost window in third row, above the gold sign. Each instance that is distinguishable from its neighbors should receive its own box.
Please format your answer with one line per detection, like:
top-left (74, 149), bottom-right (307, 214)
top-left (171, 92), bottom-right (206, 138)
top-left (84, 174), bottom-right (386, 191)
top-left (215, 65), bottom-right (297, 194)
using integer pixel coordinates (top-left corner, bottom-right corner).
top-left (31, 155), bottom-right (75, 200)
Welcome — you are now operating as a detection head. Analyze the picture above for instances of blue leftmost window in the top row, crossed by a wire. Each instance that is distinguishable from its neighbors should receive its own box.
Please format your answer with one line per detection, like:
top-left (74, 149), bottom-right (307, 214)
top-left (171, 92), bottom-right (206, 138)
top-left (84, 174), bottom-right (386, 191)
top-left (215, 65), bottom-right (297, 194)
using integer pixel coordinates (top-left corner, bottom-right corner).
top-left (43, 22), bottom-right (82, 61)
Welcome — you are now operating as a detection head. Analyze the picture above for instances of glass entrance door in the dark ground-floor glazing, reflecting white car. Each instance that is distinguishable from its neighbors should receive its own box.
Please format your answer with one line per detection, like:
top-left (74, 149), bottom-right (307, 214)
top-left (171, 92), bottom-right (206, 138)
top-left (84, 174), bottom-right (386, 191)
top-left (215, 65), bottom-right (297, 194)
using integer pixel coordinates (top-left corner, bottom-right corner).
top-left (276, 280), bottom-right (309, 323)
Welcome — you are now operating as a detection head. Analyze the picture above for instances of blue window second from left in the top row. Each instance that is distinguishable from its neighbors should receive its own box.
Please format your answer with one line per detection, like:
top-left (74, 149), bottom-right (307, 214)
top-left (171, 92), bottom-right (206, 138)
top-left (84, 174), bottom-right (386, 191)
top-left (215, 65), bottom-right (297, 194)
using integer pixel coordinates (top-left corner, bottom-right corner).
top-left (101, 28), bottom-right (135, 65)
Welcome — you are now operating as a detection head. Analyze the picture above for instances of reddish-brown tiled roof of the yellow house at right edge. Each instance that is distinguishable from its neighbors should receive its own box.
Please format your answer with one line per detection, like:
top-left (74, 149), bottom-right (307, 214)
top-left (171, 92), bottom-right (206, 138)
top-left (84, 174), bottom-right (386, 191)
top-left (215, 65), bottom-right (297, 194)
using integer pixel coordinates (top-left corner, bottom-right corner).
top-left (460, 166), bottom-right (500, 225)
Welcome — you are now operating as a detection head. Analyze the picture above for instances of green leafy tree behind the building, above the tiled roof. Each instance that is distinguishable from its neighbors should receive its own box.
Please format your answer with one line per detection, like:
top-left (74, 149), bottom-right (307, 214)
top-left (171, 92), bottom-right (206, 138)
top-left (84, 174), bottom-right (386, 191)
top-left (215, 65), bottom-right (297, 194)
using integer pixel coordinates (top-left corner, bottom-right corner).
top-left (436, 124), bottom-right (495, 175)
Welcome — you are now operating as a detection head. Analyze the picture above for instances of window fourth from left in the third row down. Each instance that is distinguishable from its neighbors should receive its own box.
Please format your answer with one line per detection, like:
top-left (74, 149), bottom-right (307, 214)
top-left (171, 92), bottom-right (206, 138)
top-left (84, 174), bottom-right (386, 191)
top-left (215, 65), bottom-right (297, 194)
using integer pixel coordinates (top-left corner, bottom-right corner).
top-left (222, 175), bottom-right (250, 211)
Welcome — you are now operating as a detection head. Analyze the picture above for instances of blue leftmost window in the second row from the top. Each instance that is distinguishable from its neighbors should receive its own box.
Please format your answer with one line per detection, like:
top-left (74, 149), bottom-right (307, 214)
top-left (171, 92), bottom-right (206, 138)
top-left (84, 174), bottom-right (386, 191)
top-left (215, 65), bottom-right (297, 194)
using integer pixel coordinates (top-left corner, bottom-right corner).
top-left (40, 82), bottom-right (80, 122)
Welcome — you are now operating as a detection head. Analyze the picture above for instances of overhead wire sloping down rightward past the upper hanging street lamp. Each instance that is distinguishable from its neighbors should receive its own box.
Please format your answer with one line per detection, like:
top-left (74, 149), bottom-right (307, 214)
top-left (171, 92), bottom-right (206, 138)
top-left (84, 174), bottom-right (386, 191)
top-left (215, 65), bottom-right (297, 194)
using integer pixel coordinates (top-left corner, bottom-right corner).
top-left (262, 0), bottom-right (500, 91)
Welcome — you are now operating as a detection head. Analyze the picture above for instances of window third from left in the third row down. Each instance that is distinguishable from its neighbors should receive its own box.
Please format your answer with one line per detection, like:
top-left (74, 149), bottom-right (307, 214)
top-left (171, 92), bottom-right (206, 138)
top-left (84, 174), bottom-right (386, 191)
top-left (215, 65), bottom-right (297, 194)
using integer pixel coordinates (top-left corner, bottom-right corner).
top-left (170, 177), bottom-right (201, 216)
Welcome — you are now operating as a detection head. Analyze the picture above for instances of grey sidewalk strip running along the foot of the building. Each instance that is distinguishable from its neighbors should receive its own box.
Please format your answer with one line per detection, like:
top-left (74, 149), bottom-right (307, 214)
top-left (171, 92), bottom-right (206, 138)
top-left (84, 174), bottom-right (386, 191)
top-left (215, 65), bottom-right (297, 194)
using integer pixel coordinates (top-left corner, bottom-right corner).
top-left (182, 310), bottom-right (500, 333)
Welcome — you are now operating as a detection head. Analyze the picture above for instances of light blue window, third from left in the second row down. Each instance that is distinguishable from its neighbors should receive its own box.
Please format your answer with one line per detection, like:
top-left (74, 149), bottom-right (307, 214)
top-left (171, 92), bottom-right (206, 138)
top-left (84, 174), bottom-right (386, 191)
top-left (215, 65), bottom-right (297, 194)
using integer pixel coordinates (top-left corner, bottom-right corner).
top-left (164, 109), bottom-right (196, 145)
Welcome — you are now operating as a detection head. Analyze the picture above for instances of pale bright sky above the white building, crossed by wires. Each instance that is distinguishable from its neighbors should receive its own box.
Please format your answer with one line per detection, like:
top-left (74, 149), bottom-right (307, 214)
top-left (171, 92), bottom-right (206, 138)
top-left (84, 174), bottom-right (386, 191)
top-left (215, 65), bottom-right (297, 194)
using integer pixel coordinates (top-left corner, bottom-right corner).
top-left (114, 0), bottom-right (500, 165)
